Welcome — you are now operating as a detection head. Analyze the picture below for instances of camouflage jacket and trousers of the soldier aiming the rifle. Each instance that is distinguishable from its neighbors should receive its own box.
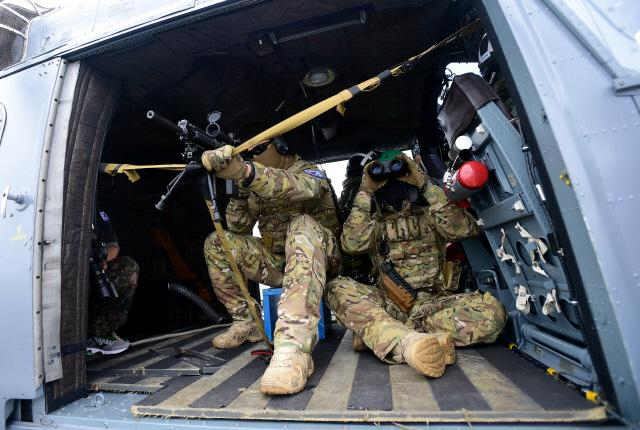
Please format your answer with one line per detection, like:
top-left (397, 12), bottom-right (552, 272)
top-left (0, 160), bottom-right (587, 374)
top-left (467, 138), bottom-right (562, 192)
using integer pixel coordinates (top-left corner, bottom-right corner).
top-left (204, 156), bottom-right (340, 352)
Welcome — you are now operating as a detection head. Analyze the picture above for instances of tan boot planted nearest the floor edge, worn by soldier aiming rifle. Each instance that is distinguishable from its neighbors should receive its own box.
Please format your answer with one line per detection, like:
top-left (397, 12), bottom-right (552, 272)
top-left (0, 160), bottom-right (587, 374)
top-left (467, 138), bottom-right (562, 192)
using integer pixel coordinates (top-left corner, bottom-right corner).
top-left (260, 346), bottom-right (314, 394)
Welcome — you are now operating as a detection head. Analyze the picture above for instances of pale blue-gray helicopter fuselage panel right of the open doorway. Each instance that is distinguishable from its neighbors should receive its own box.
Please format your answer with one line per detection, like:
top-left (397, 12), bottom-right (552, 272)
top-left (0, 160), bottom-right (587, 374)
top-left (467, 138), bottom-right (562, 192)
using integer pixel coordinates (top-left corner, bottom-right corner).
top-left (484, 0), bottom-right (640, 423)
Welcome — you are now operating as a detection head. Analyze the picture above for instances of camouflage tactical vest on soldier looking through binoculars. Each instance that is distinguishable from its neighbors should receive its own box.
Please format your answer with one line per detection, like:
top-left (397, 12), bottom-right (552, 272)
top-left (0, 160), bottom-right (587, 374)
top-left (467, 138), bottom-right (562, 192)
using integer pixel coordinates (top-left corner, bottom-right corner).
top-left (374, 204), bottom-right (445, 290)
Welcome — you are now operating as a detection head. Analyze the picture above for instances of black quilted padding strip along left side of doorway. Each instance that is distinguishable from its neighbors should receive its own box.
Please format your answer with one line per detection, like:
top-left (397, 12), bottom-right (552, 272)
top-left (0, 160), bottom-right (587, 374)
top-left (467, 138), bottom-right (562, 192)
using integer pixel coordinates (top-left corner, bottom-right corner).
top-left (47, 65), bottom-right (120, 411)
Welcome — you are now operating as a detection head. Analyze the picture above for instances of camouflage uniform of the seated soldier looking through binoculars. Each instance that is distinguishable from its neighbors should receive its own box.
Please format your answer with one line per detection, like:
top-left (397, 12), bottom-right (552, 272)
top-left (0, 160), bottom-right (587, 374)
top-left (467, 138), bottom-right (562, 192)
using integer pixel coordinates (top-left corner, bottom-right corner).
top-left (327, 184), bottom-right (506, 360)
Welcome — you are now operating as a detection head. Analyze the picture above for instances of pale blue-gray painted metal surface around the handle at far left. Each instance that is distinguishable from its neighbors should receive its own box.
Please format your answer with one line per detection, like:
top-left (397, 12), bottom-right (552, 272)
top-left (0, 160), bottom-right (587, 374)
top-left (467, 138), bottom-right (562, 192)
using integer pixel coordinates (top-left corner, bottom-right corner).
top-left (0, 60), bottom-right (61, 410)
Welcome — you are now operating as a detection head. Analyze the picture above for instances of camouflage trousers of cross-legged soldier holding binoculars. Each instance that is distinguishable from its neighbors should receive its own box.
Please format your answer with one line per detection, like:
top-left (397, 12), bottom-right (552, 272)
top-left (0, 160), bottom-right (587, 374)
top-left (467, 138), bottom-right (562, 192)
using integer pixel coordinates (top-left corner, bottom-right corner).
top-left (326, 277), bottom-right (507, 361)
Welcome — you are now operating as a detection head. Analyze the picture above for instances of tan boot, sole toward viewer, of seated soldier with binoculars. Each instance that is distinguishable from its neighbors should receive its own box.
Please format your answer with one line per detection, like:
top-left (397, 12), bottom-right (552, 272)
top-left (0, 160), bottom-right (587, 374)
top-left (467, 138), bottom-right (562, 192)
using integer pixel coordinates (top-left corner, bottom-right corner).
top-left (399, 332), bottom-right (445, 378)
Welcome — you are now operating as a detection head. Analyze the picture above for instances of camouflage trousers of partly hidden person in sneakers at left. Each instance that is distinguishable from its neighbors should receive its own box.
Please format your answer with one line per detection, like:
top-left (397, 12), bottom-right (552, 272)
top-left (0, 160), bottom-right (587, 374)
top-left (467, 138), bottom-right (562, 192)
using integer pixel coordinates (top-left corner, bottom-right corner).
top-left (88, 257), bottom-right (140, 337)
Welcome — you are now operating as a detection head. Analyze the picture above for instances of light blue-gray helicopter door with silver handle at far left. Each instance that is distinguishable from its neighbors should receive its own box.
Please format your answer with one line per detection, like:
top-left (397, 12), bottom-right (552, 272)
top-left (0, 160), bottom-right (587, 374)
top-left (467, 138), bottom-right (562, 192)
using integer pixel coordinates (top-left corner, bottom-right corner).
top-left (0, 58), bottom-right (67, 427)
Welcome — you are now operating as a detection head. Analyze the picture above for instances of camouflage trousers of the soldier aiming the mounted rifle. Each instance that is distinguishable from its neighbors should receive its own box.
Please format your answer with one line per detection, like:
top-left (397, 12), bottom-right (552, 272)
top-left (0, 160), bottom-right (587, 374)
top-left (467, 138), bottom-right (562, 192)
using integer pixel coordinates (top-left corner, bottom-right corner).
top-left (204, 215), bottom-right (340, 352)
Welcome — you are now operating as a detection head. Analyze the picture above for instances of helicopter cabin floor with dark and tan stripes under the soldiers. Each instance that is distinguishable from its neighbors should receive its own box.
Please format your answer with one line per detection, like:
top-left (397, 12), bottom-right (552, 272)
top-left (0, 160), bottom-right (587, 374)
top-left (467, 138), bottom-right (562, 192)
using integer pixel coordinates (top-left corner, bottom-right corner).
top-left (88, 328), bottom-right (607, 423)
